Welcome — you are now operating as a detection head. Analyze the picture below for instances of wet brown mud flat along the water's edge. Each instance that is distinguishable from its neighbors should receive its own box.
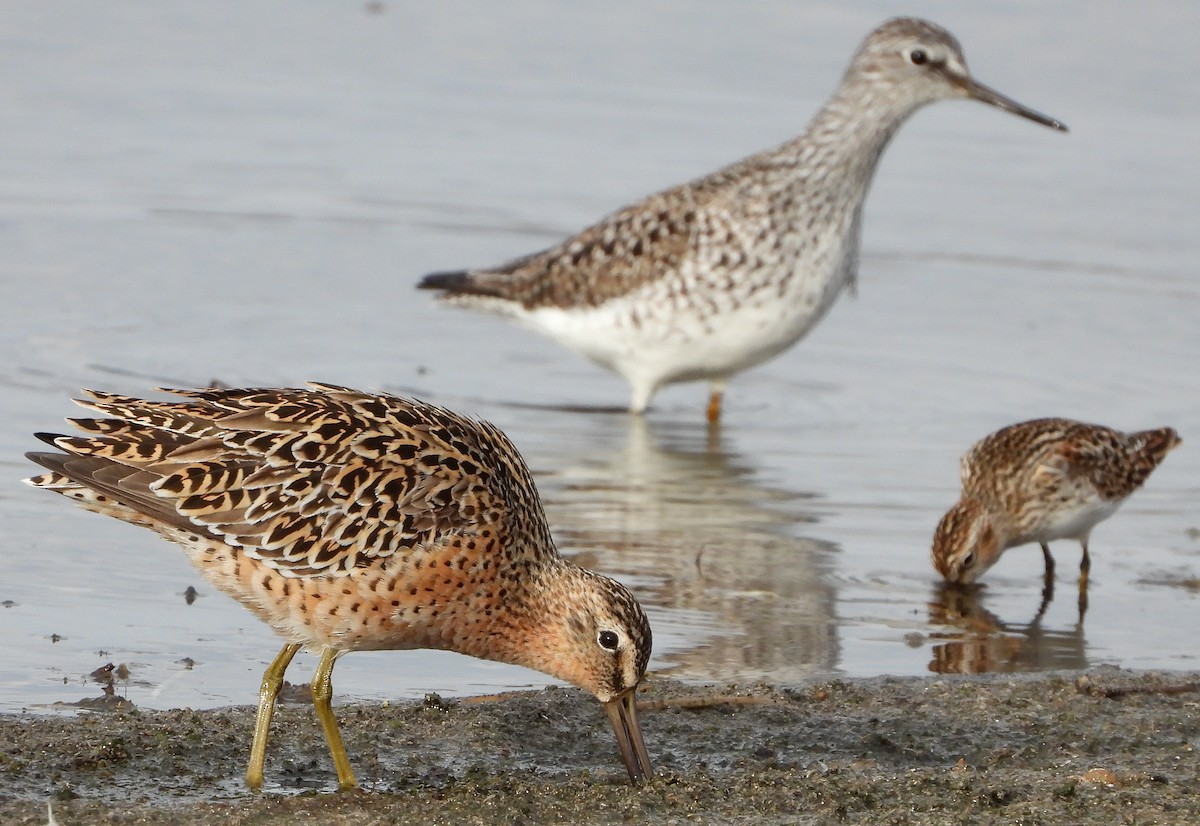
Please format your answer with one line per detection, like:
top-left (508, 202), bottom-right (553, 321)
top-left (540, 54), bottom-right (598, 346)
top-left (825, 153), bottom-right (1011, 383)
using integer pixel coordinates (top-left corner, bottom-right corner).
top-left (0, 669), bottom-right (1200, 826)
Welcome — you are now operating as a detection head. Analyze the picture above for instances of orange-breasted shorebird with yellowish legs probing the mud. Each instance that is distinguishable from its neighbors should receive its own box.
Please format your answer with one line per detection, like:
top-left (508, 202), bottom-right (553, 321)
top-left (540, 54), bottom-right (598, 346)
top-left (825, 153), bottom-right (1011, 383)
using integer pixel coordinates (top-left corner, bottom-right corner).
top-left (28, 384), bottom-right (652, 789)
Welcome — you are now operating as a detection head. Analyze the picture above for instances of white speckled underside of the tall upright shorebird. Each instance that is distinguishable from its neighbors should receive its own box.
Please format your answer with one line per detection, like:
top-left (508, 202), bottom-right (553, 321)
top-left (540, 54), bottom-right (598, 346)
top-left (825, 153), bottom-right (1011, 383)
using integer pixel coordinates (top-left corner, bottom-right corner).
top-left (450, 204), bottom-right (860, 413)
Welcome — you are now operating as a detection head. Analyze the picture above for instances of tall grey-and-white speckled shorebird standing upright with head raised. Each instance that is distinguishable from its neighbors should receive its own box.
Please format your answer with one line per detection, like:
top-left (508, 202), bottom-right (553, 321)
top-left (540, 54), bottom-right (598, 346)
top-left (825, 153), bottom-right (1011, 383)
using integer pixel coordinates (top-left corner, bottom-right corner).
top-left (419, 18), bottom-right (1067, 421)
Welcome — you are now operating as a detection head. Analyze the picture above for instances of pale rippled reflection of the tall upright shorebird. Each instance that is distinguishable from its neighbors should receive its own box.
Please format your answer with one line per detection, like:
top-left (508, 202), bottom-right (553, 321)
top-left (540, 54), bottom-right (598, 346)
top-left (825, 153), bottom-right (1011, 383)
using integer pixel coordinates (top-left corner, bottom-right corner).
top-left (524, 415), bottom-right (838, 682)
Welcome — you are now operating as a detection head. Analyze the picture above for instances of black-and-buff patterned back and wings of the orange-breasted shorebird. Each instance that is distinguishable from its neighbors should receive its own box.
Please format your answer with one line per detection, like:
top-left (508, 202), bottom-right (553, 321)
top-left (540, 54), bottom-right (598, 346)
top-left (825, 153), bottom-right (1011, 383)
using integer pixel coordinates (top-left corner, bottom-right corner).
top-left (25, 385), bottom-right (554, 576)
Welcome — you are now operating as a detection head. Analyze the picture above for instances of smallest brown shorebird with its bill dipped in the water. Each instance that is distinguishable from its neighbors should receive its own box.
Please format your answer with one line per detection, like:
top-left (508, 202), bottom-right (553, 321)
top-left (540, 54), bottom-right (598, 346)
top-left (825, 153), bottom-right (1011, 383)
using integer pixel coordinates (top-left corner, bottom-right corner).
top-left (932, 419), bottom-right (1180, 599)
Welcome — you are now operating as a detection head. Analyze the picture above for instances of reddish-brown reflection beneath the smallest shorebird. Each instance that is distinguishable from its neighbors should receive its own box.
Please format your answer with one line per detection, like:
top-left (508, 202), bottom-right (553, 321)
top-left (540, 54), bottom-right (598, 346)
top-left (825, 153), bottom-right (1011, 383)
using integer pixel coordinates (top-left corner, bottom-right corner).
top-left (929, 580), bottom-right (1088, 674)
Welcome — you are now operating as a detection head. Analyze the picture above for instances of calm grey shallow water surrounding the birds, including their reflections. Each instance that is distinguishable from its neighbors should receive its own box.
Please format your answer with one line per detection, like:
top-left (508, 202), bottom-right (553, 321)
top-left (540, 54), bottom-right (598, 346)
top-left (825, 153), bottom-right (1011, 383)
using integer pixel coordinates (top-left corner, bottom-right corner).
top-left (0, 0), bottom-right (1200, 711)
